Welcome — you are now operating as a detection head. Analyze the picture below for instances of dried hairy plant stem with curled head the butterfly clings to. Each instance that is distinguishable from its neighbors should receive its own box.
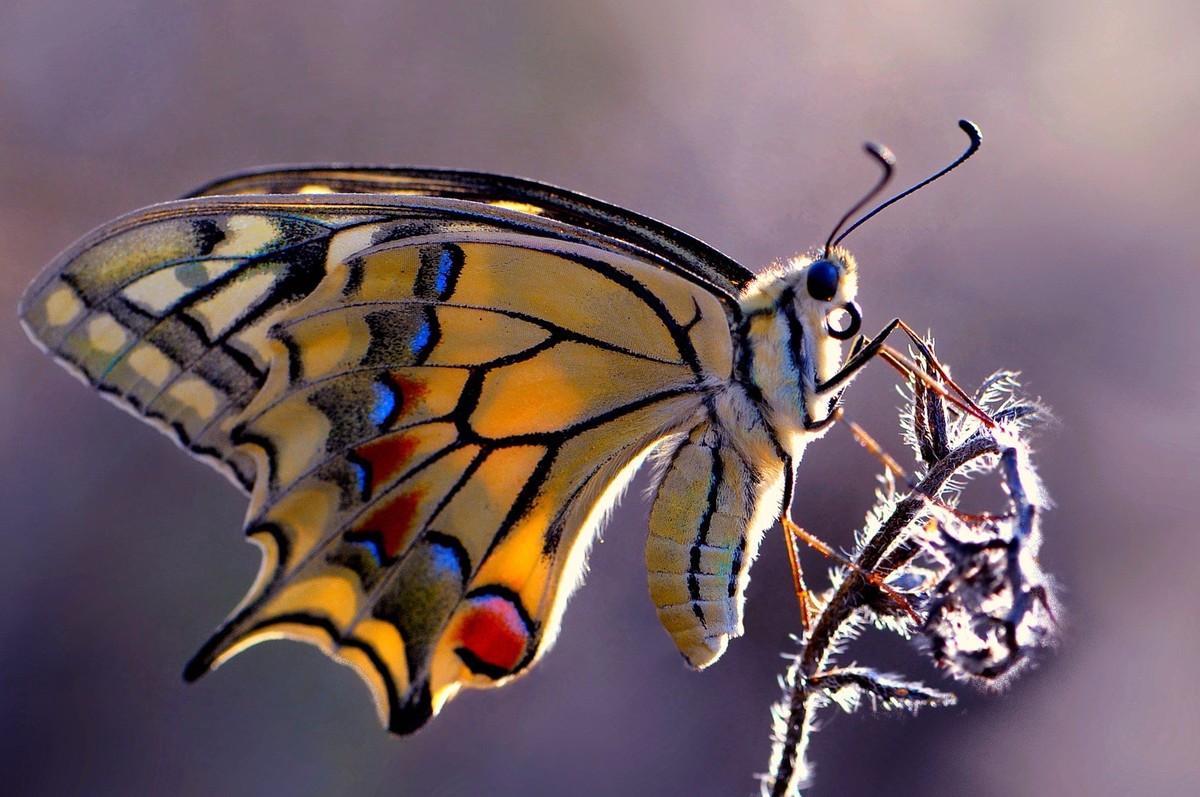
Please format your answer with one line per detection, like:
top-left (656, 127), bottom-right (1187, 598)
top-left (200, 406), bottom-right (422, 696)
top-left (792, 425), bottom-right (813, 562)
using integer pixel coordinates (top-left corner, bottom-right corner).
top-left (762, 342), bottom-right (1057, 797)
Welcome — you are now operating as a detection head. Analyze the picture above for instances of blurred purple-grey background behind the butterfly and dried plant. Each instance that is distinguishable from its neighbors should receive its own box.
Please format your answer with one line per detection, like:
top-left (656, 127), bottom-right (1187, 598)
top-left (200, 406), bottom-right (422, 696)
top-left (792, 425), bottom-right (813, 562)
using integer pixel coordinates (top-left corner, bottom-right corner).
top-left (0, 0), bottom-right (1200, 795)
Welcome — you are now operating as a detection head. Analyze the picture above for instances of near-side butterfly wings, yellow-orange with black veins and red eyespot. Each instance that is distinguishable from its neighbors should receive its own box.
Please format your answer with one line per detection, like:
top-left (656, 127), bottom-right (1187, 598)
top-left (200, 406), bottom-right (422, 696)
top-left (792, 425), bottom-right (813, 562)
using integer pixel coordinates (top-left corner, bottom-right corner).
top-left (22, 183), bottom-right (736, 732)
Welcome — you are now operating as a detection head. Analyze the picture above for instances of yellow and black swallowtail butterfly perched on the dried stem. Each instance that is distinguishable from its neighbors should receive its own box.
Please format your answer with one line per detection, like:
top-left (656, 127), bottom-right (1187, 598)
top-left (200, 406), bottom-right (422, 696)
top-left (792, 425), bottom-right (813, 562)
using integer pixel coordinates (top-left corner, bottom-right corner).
top-left (20, 121), bottom-right (978, 733)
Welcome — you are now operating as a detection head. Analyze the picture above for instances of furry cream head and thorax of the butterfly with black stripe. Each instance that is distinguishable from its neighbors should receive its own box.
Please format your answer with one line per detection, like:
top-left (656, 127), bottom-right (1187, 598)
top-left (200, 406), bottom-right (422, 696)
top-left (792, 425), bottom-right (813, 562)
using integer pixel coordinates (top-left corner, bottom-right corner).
top-left (736, 248), bottom-right (858, 461)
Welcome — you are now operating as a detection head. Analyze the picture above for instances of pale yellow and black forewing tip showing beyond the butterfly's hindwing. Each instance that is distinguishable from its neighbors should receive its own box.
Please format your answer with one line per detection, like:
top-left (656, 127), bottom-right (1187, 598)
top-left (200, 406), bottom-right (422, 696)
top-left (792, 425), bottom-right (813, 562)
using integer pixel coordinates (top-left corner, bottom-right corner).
top-left (20, 209), bottom-right (360, 487)
